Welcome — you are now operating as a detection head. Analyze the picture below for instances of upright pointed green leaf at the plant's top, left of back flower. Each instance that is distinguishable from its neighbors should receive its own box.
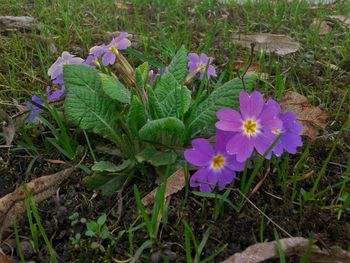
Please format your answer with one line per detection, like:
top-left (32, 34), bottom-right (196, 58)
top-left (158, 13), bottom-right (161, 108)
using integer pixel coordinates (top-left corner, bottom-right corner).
top-left (167, 47), bottom-right (187, 83)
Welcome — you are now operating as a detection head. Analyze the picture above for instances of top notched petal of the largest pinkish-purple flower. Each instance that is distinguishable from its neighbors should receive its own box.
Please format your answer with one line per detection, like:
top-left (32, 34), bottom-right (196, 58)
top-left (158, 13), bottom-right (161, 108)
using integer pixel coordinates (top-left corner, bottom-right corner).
top-left (239, 91), bottom-right (264, 120)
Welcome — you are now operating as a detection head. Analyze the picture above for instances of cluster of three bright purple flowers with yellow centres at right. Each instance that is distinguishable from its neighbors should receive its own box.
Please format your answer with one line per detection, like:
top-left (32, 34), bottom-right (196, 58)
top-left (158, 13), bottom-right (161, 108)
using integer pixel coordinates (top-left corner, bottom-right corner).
top-left (184, 91), bottom-right (302, 192)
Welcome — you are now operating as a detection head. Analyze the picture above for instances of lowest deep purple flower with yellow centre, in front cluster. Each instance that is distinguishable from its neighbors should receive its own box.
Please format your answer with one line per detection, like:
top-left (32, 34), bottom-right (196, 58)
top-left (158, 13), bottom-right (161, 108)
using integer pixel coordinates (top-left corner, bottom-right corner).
top-left (184, 131), bottom-right (244, 192)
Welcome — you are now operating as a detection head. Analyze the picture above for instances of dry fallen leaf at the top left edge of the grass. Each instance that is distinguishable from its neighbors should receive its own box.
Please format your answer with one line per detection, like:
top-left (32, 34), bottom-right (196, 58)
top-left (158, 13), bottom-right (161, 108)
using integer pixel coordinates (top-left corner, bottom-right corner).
top-left (0, 16), bottom-right (35, 32)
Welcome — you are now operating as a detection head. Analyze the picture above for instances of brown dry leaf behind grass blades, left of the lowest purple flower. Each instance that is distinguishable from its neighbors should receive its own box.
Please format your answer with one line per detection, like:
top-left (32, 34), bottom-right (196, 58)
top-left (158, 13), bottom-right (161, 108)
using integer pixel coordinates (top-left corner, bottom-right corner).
top-left (141, 168), bottom-right (186, 206)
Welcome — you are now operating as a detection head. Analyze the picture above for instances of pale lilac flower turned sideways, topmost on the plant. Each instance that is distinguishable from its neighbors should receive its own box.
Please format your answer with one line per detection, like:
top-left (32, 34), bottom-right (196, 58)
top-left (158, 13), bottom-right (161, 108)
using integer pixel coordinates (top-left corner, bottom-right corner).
top-left (102, 32), bottom-right (131, 66)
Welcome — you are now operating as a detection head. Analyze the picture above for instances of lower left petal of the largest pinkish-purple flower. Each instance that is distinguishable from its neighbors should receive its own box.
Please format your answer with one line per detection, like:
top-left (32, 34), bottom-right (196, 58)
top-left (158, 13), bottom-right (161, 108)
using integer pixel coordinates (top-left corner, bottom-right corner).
top-left (226, 133), bottom-right (254, 162)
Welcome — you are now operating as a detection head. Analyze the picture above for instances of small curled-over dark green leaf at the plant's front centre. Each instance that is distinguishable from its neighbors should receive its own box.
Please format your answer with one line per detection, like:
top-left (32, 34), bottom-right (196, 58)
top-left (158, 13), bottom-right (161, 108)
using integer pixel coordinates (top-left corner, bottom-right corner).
top-left (139, 117), bottom-right (185, 146)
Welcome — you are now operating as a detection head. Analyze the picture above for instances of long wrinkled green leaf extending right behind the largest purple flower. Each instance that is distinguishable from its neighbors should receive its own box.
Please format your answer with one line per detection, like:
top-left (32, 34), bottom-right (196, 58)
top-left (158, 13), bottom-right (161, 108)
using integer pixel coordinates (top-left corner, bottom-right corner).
top-left (187, 77), bottom-right (255, 137)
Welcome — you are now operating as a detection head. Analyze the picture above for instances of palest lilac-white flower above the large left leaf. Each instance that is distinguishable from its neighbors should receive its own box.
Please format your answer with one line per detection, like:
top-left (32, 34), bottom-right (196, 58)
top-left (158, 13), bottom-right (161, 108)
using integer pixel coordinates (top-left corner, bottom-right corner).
top-left (47, 51), bottom-right (84, 84)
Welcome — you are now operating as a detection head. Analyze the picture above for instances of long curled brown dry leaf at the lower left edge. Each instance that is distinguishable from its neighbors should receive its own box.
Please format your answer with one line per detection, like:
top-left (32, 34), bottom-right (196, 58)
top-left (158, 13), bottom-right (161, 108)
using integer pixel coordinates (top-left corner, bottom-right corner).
top-left (0, 167), bottom-right (75, 239)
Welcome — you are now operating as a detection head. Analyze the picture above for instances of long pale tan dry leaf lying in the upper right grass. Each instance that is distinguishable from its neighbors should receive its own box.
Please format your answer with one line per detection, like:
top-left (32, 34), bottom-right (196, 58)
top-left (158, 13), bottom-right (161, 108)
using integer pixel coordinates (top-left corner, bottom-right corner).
top-left (232, 33), bottom-right (300, 56)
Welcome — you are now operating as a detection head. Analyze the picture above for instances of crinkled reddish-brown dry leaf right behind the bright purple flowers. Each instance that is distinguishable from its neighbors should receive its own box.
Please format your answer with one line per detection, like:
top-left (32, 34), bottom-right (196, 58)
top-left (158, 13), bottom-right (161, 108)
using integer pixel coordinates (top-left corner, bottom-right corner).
top-left (280, 91), bottom-right (328, 139)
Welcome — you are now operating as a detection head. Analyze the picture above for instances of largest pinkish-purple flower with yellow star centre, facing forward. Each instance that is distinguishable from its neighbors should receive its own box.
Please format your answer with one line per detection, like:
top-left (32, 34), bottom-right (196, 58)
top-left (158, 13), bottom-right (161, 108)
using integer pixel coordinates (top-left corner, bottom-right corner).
top-left (216, 91), bottom-right (282, 162)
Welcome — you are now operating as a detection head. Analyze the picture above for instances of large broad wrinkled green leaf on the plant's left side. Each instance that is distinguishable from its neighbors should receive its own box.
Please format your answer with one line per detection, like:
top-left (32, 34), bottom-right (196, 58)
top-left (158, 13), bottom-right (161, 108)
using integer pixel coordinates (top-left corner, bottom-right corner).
top-left (63, 65), bottom-right (120, 142)
